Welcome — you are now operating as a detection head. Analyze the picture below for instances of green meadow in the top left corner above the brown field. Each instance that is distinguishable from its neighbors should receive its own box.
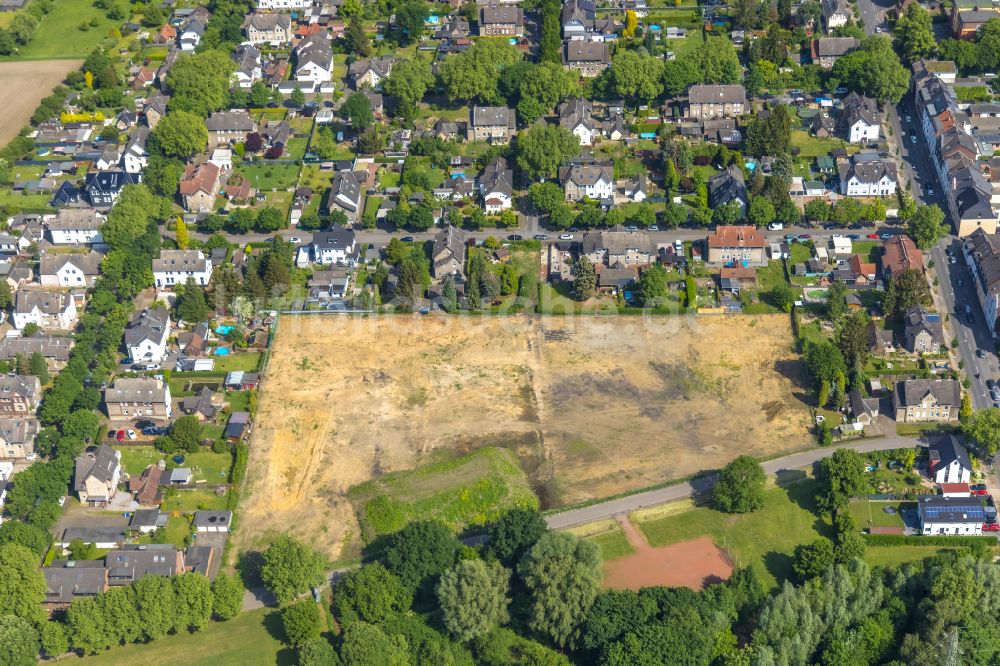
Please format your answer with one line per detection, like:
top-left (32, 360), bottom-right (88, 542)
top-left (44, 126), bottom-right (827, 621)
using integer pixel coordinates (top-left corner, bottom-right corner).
top-left (3, 0), bottom-right (121, 60)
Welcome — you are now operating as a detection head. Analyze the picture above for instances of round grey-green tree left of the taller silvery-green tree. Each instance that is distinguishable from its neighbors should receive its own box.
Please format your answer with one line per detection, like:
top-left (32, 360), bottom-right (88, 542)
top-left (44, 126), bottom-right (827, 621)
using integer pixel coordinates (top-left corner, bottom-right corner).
top-left (437, 560), bottom-right (510, 642)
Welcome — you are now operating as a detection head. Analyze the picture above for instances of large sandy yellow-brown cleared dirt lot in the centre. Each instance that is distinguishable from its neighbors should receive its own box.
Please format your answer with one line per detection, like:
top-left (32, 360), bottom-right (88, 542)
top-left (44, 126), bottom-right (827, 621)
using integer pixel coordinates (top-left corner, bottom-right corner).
top-left (239, 315), bottom-right (808, 556)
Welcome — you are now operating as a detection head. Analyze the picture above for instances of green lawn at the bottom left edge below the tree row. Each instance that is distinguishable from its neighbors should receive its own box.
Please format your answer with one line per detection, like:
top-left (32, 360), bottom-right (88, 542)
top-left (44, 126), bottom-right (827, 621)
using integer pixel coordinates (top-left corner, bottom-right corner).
top-left (84, 608), bottom-right (298, 666)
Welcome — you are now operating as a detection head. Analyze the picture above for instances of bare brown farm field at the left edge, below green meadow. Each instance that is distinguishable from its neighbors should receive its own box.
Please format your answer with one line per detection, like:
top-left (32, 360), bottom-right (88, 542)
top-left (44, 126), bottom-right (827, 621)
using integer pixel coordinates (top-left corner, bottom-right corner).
top-left (0, 60), bottom-right (83, 146)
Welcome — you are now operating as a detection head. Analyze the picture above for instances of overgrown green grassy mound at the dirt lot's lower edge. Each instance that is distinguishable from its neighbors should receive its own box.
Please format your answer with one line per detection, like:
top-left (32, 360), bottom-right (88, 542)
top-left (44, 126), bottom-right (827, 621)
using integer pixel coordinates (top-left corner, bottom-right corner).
top-left (348, 447), bottom-right (538, 537)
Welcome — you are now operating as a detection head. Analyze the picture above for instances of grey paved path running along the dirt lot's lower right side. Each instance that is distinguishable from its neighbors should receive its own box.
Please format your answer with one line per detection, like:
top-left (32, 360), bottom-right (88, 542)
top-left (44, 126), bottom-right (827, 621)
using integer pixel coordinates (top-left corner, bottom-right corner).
top-left (545, 435), bottom-right (927, 529)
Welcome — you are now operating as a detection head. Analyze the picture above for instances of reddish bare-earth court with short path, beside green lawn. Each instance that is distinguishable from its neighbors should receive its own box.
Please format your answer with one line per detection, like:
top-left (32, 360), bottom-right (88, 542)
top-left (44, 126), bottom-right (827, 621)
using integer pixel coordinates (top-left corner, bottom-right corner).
top-left (604, 517), bottom-right (733, 590)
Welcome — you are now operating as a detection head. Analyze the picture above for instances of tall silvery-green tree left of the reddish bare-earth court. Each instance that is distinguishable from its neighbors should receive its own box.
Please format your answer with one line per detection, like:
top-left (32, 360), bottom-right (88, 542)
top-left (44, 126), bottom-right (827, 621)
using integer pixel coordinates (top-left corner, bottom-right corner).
top-left (517, 532), bottom-right (601, 646)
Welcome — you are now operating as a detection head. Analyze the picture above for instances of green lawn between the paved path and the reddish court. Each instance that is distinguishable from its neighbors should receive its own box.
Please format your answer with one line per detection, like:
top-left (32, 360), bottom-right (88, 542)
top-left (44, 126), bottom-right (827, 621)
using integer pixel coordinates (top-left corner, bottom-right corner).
top-left (636, 480), bottom-right (830, 587)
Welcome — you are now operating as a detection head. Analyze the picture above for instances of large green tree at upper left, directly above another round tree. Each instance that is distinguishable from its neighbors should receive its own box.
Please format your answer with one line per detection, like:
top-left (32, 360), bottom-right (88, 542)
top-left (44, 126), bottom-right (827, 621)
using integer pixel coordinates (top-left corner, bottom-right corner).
top-left (161, 50), bottom-right (236, 116)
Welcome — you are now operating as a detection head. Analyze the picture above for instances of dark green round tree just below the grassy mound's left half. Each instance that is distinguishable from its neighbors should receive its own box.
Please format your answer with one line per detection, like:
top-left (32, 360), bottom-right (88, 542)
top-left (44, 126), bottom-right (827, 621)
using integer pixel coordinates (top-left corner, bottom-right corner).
top-left (385, 520), bottom-right (461, 591)
